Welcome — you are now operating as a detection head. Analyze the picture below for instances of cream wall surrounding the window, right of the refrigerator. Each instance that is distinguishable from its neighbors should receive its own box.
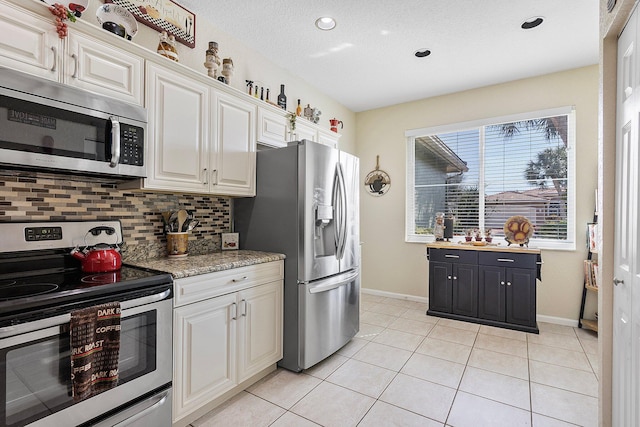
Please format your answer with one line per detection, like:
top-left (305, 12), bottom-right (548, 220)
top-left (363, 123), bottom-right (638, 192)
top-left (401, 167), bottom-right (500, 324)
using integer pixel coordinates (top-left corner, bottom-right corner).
top-left (356, 65), bottom-right (598, 322)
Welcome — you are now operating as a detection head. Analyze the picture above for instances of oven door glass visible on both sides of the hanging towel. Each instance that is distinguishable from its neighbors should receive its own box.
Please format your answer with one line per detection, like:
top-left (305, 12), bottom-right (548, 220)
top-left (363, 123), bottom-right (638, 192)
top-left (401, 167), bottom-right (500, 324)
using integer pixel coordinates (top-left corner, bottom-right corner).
top-left (0, 310), bottom-right (157, 427)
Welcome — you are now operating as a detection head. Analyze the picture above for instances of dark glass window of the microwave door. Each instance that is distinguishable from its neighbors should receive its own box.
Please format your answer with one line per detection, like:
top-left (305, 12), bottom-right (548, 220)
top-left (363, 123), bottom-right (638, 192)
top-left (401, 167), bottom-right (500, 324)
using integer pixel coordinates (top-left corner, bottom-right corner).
top-left (0, 96), bottom-right (106, 161)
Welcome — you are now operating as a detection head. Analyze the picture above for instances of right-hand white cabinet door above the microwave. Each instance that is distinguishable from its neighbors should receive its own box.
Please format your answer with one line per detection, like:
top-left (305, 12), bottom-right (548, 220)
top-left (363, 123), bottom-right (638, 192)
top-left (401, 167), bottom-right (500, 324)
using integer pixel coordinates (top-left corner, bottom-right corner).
top-left (64, 31), bottom-right (144, 105)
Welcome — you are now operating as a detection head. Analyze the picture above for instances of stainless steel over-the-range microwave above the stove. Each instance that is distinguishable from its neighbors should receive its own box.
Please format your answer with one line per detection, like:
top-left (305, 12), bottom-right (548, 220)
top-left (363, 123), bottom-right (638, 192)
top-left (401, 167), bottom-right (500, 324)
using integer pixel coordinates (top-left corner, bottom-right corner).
top-left (0, 67), bottom-right (147, 177)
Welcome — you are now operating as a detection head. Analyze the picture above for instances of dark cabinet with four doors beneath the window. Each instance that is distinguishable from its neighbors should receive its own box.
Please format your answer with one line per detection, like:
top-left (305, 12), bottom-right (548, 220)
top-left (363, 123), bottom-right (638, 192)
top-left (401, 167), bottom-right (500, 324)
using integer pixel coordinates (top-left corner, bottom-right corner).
top-left (427, 247), bottom-right (539, 333)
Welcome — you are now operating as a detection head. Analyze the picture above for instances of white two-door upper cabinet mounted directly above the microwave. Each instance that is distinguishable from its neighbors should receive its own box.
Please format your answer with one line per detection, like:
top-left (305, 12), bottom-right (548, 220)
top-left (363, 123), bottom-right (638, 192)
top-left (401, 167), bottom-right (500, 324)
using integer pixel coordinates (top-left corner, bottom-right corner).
top-left (0, 2), bottom-right (144, 105)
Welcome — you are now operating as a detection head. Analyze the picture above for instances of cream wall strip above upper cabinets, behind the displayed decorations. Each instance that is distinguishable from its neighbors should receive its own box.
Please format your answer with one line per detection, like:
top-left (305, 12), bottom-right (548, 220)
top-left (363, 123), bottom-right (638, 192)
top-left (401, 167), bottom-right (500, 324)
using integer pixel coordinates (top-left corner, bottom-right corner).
top-left (82, 0), bottom-right (355, 153)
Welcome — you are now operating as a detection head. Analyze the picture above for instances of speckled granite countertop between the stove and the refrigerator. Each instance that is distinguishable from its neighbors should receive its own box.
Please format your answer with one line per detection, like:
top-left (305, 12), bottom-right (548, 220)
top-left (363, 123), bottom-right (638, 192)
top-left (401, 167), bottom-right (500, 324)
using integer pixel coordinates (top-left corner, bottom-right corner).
top-left (125, 250), bottom-right (285, 279)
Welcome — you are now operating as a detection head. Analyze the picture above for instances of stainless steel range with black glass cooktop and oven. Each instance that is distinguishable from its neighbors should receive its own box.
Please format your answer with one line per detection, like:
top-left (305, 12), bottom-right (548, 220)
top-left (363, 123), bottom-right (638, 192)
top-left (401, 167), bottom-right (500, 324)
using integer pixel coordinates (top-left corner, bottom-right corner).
top-left (0, 221), bottom-right (173, 427)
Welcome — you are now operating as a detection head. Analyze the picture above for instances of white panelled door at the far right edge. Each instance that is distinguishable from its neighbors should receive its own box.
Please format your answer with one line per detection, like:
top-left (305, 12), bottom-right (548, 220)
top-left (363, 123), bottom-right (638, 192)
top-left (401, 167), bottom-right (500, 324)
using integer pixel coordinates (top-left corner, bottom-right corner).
top-left (612, 10), bottom-right (640, 426)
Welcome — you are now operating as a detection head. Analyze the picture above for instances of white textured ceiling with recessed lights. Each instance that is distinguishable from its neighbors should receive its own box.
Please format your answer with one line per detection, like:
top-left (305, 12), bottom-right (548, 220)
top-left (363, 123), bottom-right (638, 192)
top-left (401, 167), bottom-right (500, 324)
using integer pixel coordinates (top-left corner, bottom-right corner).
top-left (179, 0), bottom-right (599, 112)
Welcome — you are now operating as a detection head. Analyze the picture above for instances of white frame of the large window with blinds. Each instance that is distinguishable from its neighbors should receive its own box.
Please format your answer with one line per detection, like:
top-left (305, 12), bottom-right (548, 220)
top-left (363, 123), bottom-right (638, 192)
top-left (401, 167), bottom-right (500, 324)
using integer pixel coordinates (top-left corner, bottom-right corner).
top-left (405, 106), bottom-right (577, 250)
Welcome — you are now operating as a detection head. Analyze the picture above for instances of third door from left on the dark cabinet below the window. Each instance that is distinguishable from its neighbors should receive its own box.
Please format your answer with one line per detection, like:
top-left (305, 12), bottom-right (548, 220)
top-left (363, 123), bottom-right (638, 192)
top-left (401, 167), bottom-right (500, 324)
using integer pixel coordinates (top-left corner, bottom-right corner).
top-left (478, 265), bottom-right (506, 322)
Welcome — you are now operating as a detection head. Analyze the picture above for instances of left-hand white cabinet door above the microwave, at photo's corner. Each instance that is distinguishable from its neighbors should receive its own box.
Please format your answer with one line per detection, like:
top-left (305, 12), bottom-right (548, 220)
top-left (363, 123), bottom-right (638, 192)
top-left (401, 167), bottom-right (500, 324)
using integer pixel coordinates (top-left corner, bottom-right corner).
top-left (0, 4), bottom-right (62, 81)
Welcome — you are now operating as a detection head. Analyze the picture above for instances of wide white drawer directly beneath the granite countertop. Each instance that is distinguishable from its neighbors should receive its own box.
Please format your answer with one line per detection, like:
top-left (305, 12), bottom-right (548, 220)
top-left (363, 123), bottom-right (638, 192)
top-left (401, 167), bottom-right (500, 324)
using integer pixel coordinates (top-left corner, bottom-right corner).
top-left (173, 261), bottom-right (284, 307)
